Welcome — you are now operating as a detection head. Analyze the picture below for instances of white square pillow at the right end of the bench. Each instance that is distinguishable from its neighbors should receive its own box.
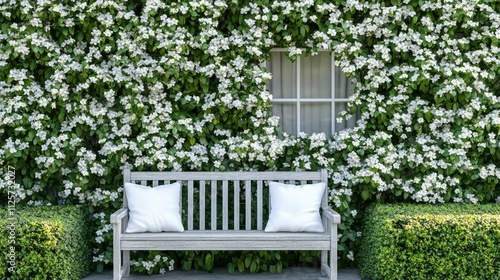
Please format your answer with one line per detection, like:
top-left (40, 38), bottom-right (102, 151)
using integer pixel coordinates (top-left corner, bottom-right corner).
top-left (265, 182), bottom-right (326, 232)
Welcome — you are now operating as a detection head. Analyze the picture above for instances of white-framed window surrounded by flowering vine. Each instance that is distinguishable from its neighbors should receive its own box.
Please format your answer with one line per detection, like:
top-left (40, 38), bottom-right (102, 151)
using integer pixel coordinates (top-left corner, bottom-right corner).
top-left (266, 49), bottom-right (356, 136)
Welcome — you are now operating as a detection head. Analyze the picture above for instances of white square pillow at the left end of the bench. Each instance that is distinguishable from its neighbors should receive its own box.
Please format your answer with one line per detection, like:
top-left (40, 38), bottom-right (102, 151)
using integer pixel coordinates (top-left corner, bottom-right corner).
top-left (125, 182), bottom-right (184, 233)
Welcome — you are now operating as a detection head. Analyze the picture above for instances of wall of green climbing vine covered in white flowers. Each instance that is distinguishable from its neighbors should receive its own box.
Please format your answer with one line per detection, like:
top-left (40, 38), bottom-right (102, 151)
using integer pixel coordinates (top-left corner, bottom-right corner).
top-left (0, 0), bottom-right (500, 271)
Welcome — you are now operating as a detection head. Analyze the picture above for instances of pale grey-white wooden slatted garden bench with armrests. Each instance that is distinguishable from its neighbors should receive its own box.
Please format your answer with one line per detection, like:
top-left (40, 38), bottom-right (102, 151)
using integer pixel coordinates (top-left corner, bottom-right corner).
top-left (111, 169), bottom-right (340, 280)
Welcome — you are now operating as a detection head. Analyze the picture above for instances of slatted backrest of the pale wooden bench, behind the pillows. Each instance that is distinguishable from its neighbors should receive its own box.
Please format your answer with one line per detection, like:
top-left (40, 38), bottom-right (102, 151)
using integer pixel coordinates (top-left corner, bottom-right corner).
top-left (123, 169), bottom-right (328, 230)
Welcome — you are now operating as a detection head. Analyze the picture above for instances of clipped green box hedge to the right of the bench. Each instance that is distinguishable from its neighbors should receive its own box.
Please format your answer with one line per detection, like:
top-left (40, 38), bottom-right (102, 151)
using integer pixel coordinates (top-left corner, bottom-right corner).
top-left (359, 204), bottom-right (500, 280)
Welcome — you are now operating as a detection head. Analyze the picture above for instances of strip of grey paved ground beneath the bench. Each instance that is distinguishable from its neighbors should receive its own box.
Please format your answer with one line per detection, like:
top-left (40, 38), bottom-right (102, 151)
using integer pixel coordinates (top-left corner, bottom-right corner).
top-left (83, 267), bottom-right (361, 280)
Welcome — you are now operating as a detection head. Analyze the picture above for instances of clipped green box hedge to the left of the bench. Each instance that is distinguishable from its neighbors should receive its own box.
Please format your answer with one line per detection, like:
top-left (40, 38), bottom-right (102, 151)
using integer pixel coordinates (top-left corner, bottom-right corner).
top-left (0, 206), bottom-right (92, 280)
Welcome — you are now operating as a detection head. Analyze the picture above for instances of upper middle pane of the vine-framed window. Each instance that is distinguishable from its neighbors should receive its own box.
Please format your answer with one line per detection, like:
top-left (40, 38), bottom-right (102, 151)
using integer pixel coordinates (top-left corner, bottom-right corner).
top-left (300, 52), bottom-right (332, 98)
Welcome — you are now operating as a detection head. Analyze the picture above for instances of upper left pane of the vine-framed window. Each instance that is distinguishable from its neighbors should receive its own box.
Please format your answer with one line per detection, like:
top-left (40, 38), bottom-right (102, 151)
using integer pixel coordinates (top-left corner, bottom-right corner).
top-left (267, 52), bottom-right (297, 98)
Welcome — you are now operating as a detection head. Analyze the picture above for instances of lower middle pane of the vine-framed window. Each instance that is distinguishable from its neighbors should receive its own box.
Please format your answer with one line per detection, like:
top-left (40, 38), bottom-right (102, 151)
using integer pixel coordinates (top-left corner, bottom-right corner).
top-left (300, 103), bottom-right (332, 135)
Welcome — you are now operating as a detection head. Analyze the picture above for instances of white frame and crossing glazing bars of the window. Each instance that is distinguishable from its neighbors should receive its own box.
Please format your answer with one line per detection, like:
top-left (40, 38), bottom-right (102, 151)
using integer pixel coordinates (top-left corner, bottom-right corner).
top-left (270, 48), bottom-right (350, 136)
